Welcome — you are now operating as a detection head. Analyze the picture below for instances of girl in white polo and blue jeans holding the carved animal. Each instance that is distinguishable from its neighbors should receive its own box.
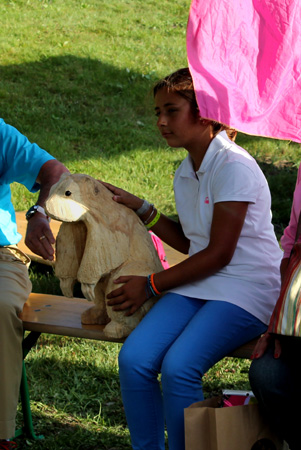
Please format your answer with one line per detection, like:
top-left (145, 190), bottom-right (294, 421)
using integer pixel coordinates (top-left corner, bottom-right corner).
top-left (103, 69), bottom-right (281, 450)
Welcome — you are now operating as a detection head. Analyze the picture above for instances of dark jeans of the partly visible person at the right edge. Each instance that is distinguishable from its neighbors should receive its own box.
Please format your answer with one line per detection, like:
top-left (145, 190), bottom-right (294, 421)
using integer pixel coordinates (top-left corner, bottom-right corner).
top-left (249, 337), bottom-right (301, 450)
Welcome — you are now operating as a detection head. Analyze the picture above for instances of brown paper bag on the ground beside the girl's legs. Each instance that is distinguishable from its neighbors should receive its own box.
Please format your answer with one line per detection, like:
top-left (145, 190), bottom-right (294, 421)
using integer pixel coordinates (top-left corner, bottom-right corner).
top-left (184, 397), bottom-right (283, 450)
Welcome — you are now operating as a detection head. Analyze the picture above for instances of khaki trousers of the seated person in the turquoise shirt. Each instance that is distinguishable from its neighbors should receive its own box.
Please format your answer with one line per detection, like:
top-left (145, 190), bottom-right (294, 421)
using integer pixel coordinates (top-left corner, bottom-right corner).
top-left (0, 246), bottom-right (32, 439)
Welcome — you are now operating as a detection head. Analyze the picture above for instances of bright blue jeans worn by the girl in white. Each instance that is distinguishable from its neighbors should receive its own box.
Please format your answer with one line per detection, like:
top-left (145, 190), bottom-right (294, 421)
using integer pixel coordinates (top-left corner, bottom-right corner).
top-left (119, 293), bottom-right (266, 450)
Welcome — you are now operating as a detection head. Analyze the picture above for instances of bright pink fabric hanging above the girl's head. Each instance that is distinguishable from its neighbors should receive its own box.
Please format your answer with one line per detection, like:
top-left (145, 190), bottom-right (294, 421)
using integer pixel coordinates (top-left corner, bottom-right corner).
top-left (187, 0), bottom-right (301, 142)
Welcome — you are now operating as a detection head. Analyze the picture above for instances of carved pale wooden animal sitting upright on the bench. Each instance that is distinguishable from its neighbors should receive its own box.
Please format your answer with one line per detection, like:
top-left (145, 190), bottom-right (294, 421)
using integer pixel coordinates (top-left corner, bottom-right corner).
top-left (46, 174), bottom-right (163, 338)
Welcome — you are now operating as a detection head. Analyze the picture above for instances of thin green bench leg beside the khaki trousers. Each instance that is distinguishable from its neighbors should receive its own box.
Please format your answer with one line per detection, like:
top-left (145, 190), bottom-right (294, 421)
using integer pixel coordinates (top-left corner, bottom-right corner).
top-left (15, 332), bottom-right (44, 440)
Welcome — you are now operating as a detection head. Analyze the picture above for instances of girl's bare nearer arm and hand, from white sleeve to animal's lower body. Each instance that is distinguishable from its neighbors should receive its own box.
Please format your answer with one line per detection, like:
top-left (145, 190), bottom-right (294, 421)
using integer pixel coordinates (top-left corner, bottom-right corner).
top-left (107, 202), bottom-right (248, 314)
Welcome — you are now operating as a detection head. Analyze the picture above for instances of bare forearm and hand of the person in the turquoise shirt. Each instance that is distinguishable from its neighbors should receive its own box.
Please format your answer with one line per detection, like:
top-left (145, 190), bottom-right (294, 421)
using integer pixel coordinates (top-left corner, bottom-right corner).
top-left (25, 159), bottom-right (69, 261)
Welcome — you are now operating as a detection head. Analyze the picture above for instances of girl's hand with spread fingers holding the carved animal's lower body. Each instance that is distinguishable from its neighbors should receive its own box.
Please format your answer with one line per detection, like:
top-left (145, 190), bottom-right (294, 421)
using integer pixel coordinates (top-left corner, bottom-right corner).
top-left (107, 275), bottom-right (149, 316)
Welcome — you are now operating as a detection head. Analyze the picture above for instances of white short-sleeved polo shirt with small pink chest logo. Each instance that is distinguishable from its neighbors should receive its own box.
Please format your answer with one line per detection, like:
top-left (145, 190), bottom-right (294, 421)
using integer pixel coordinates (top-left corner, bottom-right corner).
top-left (171, 132), bottom-right (282, 324)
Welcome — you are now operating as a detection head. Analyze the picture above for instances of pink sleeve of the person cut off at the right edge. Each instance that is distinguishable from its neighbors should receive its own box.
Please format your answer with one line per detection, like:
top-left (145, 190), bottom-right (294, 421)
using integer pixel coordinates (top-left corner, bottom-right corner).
top-left (280, 164), bottom-right (301, 258)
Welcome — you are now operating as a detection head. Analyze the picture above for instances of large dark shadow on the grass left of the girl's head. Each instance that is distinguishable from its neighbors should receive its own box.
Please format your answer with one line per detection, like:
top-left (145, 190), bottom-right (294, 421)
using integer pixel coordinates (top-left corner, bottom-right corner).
top-left (0, 55), bottom-right (159, 165)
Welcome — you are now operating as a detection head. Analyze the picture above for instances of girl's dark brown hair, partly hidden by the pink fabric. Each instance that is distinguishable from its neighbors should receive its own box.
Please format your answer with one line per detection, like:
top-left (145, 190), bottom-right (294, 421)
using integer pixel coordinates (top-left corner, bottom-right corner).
top-left (153, 67), bottom-right (237, 141)
